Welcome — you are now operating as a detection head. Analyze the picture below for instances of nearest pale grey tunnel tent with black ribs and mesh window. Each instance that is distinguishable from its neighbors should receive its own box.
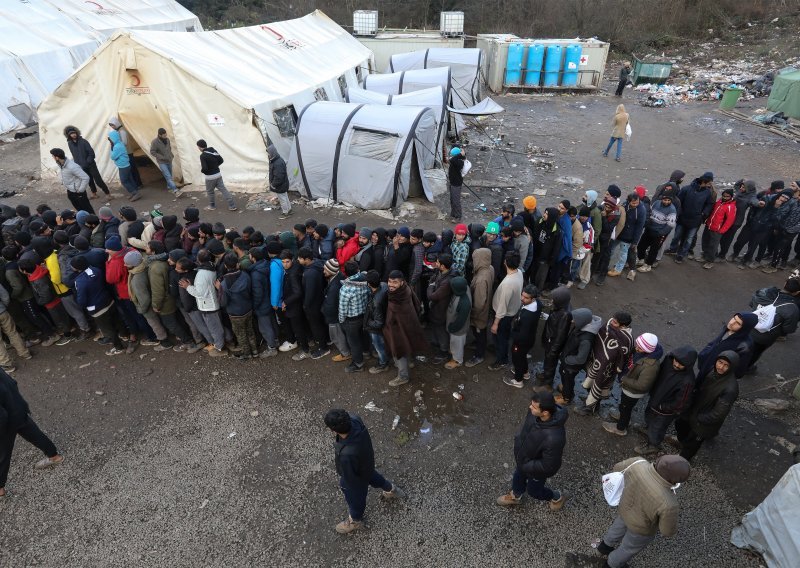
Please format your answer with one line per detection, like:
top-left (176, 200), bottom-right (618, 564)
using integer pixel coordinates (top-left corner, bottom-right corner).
top-left (288, 102), bottom-right (436, 209)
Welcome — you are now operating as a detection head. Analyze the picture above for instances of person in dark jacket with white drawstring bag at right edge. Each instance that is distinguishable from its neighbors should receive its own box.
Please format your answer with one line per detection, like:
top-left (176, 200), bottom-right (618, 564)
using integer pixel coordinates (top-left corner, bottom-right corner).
top-left (747, 278), bottom-right (800, 375)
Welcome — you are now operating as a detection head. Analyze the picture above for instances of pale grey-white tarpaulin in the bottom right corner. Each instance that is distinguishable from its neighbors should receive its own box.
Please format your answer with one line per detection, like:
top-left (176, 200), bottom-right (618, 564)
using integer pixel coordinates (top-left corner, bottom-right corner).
top-left (731, 464), bottom-right (800, 568)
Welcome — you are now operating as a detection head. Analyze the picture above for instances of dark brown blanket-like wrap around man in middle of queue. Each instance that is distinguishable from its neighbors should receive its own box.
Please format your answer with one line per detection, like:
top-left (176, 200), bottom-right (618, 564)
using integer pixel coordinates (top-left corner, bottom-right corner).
top-left (383, 284), bottom-right (428, 359)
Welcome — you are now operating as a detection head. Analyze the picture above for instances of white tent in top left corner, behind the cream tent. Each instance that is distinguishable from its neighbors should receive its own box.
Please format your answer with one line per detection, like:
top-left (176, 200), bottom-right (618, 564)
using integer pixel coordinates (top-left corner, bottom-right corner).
top-left (0, 0), bottom-right (203, 132)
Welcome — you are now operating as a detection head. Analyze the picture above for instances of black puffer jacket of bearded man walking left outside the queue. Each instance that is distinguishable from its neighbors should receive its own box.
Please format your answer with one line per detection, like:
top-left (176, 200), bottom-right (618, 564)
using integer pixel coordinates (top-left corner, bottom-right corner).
top-left (514, 406), bottom-right (567, 481)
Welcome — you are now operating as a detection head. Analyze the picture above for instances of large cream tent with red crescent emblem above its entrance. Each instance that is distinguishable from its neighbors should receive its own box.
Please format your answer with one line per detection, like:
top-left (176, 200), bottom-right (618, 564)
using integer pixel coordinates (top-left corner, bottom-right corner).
top-left (39, 11), bottom-right (372, 192)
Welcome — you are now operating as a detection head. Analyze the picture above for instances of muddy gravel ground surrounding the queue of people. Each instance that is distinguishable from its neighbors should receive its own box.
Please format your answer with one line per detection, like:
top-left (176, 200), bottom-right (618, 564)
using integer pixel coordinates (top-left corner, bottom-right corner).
top-left (0, 85), bottom-right (800, 567)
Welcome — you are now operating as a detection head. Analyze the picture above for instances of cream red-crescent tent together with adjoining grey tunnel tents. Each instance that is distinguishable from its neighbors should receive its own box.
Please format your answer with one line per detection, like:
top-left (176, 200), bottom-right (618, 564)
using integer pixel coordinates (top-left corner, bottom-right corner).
top-left (21, 11), bottom-right (490, 209)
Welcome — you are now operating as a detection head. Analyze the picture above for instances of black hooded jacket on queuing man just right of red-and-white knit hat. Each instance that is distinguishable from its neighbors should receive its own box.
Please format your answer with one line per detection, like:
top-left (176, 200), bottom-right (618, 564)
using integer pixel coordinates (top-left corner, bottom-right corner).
top-left (648, 347), bottom-right (696, 416)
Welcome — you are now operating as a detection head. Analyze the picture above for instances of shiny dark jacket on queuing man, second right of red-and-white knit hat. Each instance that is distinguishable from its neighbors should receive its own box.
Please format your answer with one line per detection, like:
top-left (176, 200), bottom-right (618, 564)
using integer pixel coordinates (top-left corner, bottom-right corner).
top-left (681, 351), bottom-right (739, 440)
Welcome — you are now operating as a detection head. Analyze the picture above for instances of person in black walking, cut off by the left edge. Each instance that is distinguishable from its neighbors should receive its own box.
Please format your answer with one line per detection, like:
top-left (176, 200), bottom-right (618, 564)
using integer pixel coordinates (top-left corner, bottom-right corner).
top-left (0, 370), bottom-right (64, 498)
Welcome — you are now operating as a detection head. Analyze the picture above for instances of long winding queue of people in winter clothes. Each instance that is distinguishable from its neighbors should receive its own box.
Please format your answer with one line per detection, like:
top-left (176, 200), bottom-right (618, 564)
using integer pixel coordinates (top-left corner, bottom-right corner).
top-left (0, 149), bottom-right (800, 566)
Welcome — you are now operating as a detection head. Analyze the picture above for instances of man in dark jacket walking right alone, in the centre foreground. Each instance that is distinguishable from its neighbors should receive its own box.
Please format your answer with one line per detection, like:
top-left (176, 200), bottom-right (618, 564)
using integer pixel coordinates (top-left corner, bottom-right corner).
top-left (325, 408), bottom-right (401, 534)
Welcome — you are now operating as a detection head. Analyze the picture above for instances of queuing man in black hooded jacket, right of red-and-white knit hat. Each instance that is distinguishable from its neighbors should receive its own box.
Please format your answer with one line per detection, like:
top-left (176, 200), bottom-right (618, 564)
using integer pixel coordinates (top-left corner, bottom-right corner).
top-left (633, 345), bottom-right (697, 456)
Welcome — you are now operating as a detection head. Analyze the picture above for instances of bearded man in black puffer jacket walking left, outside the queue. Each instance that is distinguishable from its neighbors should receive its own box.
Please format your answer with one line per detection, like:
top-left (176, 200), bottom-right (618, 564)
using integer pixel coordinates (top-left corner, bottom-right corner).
top-left (497, 392), bottom-right (567, 511)
